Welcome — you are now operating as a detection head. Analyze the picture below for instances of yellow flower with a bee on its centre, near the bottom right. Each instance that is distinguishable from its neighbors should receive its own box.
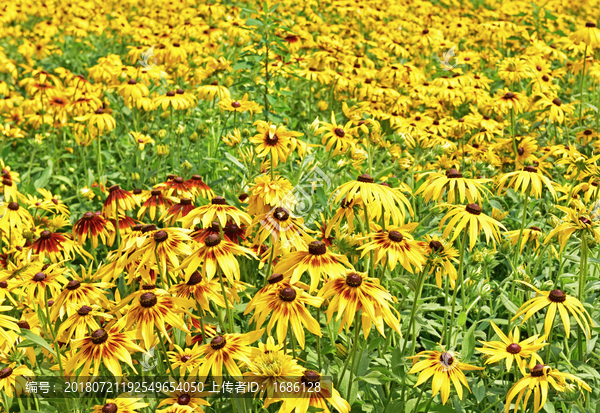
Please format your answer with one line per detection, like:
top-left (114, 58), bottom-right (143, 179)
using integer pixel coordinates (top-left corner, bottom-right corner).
top-left (407, 350), bottom-right (484, 404)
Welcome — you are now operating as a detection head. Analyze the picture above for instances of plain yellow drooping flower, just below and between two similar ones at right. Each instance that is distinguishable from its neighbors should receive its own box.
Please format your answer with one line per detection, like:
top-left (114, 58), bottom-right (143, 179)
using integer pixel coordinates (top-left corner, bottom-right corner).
top-left (440, 204), bottom-right (506, 250)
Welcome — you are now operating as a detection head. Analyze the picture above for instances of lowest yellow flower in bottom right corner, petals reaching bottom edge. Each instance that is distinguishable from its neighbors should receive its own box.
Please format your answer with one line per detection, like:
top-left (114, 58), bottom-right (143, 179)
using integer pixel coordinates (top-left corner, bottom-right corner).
top-left (504, 358), bottom-right (592, 413)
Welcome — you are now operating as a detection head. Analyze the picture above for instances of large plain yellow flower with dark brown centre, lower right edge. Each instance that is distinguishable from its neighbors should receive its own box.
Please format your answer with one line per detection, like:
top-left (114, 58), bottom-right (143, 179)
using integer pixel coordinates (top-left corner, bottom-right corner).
top-left (512, 281), bottom-right (594, 339)
